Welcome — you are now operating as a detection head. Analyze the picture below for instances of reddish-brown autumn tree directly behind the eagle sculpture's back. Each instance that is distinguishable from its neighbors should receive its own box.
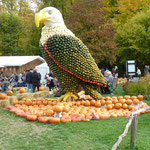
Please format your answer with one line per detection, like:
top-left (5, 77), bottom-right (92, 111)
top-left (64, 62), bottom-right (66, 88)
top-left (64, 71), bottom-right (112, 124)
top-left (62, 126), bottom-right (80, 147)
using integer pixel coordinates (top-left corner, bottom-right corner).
top-left (67, 0), bottom-right (117, 65)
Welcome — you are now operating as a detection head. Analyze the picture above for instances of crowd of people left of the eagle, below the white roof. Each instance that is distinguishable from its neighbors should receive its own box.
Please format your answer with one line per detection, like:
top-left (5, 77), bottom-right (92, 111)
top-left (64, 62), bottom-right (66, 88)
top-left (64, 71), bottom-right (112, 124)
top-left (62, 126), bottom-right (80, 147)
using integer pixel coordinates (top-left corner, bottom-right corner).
top-left (0, 69), bottom-right (59, 93)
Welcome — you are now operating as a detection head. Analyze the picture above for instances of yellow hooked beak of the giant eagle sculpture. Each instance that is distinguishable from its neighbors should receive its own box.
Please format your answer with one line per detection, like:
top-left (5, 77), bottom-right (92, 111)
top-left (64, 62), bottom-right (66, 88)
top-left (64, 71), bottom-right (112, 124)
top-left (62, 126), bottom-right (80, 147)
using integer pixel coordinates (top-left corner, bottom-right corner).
top-left (35, 12), bottom-right (51, 27)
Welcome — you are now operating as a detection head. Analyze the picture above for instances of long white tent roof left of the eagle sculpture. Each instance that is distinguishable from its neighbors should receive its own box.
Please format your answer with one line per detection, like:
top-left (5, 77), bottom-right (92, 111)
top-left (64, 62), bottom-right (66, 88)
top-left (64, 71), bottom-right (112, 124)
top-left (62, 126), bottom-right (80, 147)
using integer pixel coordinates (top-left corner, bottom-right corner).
top-left (0, 56), bottom-right (45, 66)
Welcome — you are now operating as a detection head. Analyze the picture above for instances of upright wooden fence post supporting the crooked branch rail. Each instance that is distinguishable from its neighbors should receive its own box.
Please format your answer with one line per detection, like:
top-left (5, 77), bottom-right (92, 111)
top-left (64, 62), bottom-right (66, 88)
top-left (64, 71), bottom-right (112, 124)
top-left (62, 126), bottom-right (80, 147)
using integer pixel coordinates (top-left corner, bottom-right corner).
top-left (130, 114), bottom-right (138, 147)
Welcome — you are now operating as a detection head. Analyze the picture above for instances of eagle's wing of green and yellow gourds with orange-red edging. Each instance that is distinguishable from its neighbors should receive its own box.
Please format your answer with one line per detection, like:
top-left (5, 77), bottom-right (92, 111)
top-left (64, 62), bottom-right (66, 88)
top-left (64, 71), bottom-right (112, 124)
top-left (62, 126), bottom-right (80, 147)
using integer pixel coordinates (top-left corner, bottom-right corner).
top-left (45, 35), bottom-right (106, 85)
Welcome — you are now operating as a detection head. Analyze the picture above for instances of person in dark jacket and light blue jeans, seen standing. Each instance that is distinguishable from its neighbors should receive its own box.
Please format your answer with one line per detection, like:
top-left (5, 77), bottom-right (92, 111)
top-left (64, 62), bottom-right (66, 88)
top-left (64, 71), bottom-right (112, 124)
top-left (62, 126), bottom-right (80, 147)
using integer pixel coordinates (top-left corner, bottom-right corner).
top-left (26, 69), bottom-right (33, 93)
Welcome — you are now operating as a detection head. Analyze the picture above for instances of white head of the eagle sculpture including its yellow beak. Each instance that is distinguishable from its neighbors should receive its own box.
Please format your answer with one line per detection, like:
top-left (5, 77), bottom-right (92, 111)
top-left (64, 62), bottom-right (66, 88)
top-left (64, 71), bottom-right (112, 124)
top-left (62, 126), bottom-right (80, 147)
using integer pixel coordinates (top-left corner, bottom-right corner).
top-left (35, 7), bottom-right (64, 27)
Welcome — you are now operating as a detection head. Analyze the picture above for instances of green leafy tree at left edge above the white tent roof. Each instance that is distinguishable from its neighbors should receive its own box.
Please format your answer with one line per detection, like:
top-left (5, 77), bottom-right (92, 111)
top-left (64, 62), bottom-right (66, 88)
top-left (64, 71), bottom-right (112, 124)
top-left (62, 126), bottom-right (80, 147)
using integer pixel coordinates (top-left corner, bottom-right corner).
top-left (0, 12), bottom-right (23, 55)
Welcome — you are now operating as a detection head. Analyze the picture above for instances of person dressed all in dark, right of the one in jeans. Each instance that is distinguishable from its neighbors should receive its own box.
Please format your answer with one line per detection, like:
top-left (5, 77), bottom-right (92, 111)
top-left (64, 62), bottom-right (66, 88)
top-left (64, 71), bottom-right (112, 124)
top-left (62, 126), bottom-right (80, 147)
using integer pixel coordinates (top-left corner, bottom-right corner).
top-left (32, 69), bottom-right (40, 93)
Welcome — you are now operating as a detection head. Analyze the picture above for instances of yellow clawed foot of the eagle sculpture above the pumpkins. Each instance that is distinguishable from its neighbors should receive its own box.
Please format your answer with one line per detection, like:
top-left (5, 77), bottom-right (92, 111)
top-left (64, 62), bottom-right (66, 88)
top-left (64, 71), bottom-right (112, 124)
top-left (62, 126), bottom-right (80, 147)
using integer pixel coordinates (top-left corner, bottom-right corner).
top-left (57, 92), bottom-right (79, 102)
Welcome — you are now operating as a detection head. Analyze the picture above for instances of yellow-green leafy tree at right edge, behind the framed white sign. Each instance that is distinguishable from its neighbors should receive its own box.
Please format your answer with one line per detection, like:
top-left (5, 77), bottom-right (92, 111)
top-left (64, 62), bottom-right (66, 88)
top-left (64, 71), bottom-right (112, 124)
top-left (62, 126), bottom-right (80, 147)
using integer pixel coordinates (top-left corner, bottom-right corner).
top-left (115, 10), bottom-right (150, 66)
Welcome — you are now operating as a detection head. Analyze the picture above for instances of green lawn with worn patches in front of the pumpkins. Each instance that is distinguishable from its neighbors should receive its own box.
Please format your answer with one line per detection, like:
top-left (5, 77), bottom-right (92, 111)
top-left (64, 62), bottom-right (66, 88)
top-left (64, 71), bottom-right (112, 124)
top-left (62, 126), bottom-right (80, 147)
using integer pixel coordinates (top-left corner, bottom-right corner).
top-left (0, 87), bottom-right (150, 150)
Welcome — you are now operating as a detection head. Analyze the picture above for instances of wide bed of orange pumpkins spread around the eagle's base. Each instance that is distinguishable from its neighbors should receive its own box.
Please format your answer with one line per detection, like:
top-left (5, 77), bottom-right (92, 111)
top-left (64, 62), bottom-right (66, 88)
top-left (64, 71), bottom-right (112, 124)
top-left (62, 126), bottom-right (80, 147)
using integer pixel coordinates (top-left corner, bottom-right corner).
top-left (7, 95), bottom-right (149, 123)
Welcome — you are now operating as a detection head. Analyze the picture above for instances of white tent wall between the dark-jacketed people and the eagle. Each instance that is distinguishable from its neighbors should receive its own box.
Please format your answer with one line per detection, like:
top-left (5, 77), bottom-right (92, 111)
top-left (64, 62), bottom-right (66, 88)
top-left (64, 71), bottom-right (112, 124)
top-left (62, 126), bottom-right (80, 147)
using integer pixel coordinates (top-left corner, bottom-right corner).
top-left (35, 62), bottom-right (49, 82)
